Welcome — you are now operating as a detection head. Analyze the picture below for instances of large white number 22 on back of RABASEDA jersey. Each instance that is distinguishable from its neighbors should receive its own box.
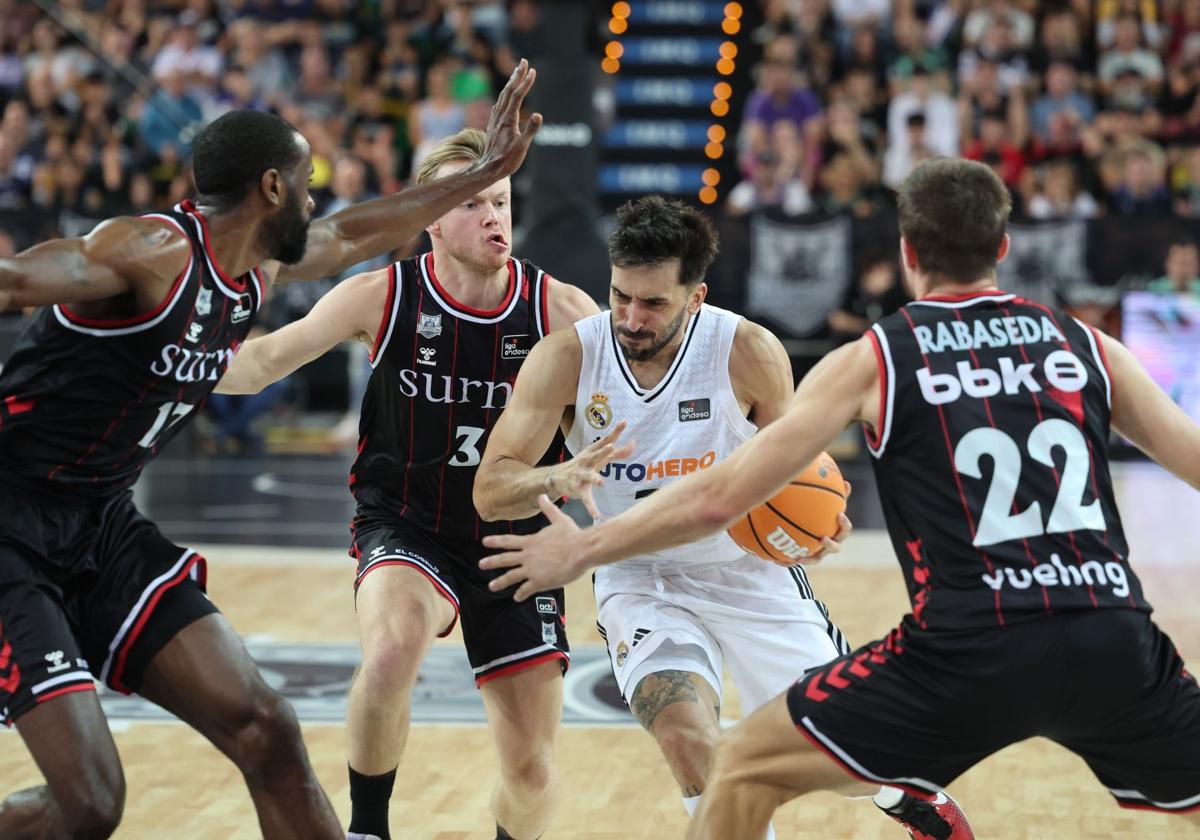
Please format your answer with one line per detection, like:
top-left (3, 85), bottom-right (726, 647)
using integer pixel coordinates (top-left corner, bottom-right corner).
top-left (954, 419), bottom-right (1105, 546)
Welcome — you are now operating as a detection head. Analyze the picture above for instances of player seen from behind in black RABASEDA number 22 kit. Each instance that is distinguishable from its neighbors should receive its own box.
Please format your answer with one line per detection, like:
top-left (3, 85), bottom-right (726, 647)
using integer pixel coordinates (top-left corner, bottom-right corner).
top-left (484, 154), bottom-right (1200, 839)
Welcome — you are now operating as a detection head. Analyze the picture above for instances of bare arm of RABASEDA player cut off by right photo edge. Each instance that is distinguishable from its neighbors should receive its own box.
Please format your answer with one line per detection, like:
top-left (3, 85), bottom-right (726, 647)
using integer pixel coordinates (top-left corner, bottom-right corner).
top-left (1097, 324), bottom-right (1200, 490)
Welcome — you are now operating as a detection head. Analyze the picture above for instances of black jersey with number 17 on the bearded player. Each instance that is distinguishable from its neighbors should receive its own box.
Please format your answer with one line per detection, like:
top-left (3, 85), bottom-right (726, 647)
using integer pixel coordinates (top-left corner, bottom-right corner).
top-left (0, 202), bottom-right (266, 498)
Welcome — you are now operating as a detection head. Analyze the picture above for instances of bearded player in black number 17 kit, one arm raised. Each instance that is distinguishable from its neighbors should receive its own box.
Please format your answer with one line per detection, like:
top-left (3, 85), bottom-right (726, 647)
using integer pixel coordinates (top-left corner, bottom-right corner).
top-left (0, 61), bottom-right (540, 840)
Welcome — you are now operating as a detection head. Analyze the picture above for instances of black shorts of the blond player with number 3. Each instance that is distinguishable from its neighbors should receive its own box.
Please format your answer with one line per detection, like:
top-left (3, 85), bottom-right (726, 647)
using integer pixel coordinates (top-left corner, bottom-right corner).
top-left (350, 516), bottom-right (570, 686)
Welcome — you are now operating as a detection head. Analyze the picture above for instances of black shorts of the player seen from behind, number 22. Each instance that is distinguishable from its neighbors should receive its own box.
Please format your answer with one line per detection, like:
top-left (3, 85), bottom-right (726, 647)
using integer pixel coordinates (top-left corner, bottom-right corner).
top-left (787, 608), bottom-right (1200, 812)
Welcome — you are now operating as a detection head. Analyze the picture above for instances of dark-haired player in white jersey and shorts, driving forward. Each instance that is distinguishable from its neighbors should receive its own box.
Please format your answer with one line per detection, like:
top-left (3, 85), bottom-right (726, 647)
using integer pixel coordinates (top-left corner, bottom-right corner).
top-left (474, 196), bottom-right (970, 839)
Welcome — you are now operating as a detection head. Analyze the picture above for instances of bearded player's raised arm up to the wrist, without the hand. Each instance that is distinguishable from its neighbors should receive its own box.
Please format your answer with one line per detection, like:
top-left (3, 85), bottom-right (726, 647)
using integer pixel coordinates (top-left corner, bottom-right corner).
top-left (280, 163), bottom-right (500, 281)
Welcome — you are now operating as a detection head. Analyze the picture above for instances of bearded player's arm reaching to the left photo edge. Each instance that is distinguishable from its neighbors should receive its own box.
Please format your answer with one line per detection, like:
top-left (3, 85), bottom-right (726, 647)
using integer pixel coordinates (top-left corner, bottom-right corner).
top-left (0, 216), bottom-right (192, 312)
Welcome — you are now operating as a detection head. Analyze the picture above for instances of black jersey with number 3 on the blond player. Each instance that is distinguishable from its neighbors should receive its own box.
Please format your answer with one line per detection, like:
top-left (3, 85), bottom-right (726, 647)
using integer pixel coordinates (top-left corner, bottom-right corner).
top-left (350, 253), bottom-right (563, 540)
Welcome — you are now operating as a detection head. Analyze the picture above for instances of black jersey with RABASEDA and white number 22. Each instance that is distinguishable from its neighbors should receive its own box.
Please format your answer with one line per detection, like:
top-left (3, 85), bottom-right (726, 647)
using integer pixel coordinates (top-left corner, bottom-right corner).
top-left (868, 290), bottom-right (1150, 628)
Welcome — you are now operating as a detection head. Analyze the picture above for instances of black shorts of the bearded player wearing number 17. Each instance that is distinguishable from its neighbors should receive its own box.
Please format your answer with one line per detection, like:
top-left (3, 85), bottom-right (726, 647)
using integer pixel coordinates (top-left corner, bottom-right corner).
top-left (0, 485), bottom-right (217, 725)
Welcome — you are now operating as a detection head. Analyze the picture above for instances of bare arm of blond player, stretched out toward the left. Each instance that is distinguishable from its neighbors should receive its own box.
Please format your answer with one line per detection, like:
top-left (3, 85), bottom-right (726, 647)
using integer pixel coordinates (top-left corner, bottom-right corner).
top-left (216, 268), bottom-right (391, 394)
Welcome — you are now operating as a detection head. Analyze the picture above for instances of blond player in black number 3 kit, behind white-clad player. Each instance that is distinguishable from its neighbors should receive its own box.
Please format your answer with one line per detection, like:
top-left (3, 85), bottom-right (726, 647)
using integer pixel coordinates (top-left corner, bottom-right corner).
top-left (217, 128), bottom-right (604, 840)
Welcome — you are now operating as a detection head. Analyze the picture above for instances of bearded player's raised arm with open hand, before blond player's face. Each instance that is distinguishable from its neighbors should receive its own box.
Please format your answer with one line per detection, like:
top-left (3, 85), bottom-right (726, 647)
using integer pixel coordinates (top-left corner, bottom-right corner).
top-left (268, 59), bottom-right (541, 282)
